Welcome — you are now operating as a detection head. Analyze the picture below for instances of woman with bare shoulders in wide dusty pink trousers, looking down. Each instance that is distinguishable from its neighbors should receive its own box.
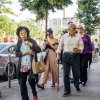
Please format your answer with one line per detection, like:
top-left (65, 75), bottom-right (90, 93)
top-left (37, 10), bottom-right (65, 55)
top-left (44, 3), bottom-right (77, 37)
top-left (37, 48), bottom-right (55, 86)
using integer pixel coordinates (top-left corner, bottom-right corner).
top-left (38, 29), bottom-right (58, 89)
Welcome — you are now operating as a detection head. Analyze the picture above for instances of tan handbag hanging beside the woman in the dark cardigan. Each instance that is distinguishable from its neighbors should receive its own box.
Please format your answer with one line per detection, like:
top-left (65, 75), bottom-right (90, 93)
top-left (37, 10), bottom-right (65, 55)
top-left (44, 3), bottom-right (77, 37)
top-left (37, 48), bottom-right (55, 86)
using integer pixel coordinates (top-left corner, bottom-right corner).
top-left (32, 52), bottom-right (45, 74)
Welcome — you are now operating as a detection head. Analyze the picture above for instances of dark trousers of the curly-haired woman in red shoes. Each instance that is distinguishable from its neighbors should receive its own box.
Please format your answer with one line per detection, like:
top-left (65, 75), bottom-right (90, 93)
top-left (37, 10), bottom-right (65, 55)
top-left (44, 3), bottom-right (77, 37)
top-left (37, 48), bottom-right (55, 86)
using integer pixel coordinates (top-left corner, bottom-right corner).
top-left (20, 72), bottom-right (37, 100)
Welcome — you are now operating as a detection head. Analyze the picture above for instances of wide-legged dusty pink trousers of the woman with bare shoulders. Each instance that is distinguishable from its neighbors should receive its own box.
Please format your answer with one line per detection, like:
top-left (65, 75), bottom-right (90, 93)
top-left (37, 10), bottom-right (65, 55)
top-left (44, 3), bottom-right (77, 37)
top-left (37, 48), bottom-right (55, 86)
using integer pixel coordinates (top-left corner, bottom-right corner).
top-left (39, 50), bottom-right (58, 84)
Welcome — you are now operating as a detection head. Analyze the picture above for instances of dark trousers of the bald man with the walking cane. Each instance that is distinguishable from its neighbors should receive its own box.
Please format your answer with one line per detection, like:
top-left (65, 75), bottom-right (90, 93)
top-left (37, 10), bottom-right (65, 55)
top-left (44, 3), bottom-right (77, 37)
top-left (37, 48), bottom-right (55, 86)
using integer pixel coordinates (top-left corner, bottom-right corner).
top-left (62, 52), bottom-right (80, 92)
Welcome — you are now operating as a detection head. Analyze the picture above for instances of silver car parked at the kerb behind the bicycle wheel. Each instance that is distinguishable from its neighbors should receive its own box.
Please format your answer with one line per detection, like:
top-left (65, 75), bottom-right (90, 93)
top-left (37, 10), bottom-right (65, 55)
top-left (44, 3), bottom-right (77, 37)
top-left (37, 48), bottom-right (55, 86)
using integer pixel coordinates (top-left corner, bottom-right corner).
top-left (0, 43), bottom-right (18, 76)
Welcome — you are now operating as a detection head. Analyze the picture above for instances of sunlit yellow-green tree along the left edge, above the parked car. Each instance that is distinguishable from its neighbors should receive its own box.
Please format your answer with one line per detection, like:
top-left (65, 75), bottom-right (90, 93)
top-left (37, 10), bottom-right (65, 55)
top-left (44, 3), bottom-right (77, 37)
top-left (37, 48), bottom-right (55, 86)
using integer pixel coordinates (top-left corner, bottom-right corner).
top-left (0, 0), bottom-right (17, 37)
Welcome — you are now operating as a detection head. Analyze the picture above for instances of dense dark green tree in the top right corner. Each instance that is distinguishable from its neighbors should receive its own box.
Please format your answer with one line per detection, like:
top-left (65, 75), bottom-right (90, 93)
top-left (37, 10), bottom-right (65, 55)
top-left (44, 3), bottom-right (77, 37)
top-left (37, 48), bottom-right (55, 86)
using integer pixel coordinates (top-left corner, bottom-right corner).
top-left (76, 0), bottom-right (100, 35)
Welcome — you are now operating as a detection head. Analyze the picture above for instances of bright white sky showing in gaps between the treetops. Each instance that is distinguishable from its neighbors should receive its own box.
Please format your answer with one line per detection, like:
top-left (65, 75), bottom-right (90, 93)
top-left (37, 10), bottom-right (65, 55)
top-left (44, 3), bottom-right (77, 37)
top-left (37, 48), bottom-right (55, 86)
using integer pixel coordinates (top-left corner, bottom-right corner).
top-left (10, 0), bottom-right (77, 21)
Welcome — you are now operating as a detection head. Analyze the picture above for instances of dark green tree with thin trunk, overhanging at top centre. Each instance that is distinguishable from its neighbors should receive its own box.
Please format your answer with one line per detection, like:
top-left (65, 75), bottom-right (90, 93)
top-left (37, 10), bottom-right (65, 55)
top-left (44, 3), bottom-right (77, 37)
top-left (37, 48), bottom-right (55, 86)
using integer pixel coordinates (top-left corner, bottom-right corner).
top-left (19, 0), bottom-right (72, 37)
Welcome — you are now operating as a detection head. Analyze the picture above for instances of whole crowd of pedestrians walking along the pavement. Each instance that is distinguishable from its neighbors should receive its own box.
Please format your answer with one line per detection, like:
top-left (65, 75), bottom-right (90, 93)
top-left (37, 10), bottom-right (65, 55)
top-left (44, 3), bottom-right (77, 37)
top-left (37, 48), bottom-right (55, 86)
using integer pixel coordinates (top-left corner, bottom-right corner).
top-left (0, 22), bottom-right (100, 100)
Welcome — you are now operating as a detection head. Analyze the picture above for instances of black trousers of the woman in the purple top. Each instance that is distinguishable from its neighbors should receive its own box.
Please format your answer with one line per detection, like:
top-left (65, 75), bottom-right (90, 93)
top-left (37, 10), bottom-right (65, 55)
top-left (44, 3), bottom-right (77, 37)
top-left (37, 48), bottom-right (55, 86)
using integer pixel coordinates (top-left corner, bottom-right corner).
top-left (80, 53), bottom-right (89, 83)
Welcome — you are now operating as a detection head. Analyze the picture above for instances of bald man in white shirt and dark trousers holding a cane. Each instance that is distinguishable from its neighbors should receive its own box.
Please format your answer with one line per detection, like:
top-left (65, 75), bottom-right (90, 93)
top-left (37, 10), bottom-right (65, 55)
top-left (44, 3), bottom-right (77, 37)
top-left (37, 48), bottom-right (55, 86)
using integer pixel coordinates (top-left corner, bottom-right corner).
top-left (57, 23), bottom-right (84, 97)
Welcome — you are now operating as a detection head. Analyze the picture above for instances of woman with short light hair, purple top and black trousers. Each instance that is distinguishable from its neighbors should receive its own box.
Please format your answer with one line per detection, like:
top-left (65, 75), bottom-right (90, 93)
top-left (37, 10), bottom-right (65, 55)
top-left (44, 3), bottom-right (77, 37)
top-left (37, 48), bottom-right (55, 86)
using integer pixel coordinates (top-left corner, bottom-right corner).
top-left (78, 25), bottom-right (93, 86)
